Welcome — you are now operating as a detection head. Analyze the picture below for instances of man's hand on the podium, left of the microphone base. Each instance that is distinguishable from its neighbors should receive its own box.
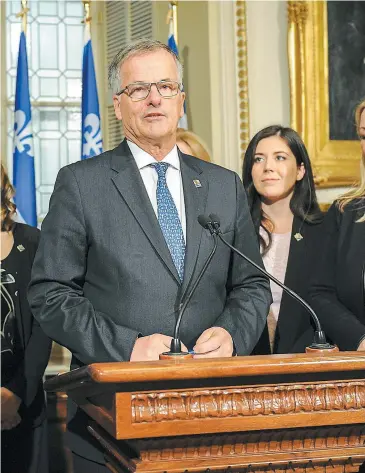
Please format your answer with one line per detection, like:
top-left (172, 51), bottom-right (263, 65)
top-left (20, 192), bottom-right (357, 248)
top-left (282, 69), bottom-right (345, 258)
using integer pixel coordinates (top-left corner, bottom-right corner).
top-left (130, 333), bottom-right (188, 361)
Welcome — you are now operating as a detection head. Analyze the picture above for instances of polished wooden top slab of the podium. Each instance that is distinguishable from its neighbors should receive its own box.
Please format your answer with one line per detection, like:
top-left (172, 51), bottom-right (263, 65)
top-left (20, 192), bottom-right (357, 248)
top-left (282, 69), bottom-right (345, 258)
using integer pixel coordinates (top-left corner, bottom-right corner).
top-left (45, 352), bottom-right (365, 391)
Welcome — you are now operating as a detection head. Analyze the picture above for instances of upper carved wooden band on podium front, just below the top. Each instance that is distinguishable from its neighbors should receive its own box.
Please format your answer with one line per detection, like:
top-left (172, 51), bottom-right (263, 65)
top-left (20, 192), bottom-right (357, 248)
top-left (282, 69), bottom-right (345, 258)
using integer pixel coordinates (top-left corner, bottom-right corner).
top-left (131, 381), bottom-right (365, 424)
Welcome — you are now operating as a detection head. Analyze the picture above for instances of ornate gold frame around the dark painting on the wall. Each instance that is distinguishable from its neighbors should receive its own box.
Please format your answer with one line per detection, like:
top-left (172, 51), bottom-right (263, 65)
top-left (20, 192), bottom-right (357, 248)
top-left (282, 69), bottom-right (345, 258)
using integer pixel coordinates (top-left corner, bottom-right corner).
top-left (288, 0), bottom-right (365, 187)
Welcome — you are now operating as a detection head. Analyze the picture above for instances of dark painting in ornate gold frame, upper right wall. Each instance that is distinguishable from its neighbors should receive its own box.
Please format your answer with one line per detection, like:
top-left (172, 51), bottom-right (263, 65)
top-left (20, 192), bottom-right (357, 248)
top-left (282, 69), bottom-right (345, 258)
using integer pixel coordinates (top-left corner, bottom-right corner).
top-left (288, 0), bottom-right (365, 187)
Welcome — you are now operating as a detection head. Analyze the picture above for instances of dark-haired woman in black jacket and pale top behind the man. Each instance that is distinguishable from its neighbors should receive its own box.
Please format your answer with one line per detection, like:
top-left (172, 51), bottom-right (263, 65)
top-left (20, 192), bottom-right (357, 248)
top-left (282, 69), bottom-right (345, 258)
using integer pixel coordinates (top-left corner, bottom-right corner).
top-left (243, 125), bottom-right (322, 355)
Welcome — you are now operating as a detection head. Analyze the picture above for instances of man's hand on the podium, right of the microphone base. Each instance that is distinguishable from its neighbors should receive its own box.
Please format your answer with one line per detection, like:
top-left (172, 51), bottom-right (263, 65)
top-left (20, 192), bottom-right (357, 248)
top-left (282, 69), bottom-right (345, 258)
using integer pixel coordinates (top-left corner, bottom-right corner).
top-left (194, 327), bottom-right (233, 358)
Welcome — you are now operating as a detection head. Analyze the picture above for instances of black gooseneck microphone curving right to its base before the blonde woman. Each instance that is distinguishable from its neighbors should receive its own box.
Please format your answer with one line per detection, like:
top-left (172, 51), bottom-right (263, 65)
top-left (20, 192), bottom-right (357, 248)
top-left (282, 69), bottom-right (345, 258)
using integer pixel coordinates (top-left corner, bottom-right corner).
top-left (198, 214), bottom-right (336, 350)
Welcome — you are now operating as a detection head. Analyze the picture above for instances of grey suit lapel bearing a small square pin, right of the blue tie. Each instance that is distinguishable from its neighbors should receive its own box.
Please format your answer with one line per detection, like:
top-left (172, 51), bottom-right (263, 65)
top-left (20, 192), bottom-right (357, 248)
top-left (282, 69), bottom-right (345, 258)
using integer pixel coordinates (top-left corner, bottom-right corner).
top-left (179, 153), bottom-right (209, 297)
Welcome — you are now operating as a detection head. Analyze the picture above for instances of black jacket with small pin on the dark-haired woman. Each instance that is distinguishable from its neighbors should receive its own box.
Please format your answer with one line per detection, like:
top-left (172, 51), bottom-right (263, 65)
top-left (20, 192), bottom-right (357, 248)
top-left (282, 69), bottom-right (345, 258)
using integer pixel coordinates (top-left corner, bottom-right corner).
top-left (252, 217), bottom-right (322, 355)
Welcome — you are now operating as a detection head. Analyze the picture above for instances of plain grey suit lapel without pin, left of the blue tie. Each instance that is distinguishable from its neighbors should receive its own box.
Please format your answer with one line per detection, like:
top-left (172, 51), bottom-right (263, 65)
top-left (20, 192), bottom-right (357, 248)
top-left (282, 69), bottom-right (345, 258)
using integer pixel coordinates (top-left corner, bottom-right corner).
top-left (111, 140), bottom-right (180, 283)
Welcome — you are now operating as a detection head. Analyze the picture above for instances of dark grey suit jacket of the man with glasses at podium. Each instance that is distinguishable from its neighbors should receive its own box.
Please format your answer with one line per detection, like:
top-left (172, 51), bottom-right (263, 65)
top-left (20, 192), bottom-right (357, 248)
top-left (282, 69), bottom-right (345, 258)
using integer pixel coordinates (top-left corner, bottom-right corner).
top-left (29, 141), bottom-right (271, 461)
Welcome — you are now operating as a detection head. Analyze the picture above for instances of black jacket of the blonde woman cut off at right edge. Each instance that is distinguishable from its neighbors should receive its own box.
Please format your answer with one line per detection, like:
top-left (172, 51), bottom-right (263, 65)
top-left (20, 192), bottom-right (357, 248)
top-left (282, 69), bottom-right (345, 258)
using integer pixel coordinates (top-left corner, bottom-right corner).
top-left (310, 199), bottom-right (365, 350)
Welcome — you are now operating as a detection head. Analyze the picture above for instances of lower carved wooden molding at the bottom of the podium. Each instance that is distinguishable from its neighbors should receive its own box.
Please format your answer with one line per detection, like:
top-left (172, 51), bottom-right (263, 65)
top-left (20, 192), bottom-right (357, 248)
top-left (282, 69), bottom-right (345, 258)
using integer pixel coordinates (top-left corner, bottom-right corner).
top-left (89, 424), bottom-right (365, 473)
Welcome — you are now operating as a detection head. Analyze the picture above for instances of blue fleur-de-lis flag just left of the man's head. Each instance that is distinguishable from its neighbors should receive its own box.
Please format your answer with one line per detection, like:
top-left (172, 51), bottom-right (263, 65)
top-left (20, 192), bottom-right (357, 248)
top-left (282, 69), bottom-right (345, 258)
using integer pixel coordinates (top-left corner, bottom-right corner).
top-left (81, 23), bottom-right (103, 159)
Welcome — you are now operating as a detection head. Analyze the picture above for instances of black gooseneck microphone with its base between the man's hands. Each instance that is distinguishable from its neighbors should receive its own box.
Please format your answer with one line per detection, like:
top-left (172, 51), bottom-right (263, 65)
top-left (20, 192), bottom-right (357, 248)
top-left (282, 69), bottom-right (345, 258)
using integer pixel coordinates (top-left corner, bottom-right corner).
top-left (160, 219), bottom-right (218, 358)
